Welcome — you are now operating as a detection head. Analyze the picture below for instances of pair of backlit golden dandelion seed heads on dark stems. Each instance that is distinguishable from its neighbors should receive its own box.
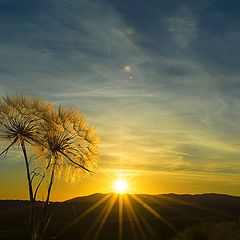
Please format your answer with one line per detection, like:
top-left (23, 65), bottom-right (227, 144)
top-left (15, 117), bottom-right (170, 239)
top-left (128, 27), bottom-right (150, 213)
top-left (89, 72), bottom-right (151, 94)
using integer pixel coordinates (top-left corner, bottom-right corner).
top-left (0, 96), bottom-right (99, 239)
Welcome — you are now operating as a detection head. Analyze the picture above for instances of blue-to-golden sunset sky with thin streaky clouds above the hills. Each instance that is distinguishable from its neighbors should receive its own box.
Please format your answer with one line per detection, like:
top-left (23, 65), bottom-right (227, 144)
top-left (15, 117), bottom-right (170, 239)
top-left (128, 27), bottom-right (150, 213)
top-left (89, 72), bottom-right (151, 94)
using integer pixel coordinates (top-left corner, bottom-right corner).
top-left (0, 0), bottom-right (240, 201)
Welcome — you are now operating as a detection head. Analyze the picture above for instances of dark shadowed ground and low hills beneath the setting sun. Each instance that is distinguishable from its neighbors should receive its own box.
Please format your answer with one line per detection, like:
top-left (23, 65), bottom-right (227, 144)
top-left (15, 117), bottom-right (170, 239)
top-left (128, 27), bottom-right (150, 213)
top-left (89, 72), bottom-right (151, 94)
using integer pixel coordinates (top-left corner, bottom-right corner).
top-left (0, 194), bottom-right (240, 240)
